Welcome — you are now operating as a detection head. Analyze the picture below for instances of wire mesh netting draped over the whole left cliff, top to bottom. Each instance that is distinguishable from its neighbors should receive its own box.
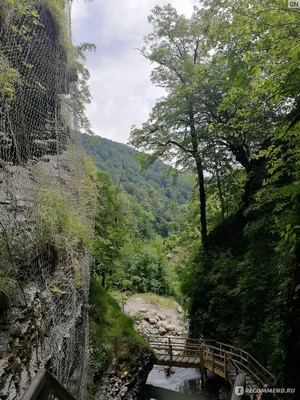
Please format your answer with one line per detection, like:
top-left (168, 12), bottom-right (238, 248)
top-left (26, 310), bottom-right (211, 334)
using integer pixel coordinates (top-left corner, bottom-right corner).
top-left (0, 0), bottom-right (95, 400)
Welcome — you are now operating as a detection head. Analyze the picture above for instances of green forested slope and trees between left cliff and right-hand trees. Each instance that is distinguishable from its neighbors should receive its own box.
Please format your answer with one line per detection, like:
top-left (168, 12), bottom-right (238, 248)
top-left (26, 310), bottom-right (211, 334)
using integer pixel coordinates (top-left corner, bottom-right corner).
top-left (83, 135), bottom-right (193, 299)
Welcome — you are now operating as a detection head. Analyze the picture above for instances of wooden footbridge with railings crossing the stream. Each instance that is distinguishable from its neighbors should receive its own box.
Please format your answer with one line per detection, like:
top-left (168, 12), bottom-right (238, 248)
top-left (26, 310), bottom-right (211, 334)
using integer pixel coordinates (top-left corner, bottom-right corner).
top-left (148, 336), bottom-right (276, 389)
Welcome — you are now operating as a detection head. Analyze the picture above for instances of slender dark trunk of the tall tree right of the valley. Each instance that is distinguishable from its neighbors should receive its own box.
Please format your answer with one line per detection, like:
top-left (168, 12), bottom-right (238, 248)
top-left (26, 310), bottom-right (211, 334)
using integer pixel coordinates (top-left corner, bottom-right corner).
top-left (190, 110), bottom-right (208, 253)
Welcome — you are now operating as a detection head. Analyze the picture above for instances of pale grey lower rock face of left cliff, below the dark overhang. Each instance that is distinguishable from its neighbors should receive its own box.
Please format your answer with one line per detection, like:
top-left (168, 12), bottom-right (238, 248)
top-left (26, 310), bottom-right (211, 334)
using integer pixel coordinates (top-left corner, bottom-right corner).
top-left (0, 153), bottom-right (94, 400)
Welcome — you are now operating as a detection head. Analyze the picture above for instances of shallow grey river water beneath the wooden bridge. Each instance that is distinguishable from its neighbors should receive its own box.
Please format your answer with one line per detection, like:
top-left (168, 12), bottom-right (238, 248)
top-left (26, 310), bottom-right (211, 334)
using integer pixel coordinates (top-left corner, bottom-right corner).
top-left (146, 366), bottom-right (219, 400)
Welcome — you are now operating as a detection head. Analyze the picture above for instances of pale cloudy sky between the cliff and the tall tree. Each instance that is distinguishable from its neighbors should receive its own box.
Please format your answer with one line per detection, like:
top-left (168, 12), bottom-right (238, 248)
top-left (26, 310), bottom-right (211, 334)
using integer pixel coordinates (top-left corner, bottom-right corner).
top-left (72, 0), bottom-right (198, 143)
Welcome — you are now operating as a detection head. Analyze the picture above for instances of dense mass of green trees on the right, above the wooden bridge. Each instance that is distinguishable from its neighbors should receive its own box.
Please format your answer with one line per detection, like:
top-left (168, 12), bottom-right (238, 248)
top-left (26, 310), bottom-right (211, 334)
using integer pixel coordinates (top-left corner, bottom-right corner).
top-left (125, 0), bottom-right (300, 394)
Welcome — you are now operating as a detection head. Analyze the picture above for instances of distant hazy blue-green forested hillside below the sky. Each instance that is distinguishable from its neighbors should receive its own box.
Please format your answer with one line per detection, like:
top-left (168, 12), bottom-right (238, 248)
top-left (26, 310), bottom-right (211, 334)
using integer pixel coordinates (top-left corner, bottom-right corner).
top-left (82, 134), bottom-right (193, 237)
